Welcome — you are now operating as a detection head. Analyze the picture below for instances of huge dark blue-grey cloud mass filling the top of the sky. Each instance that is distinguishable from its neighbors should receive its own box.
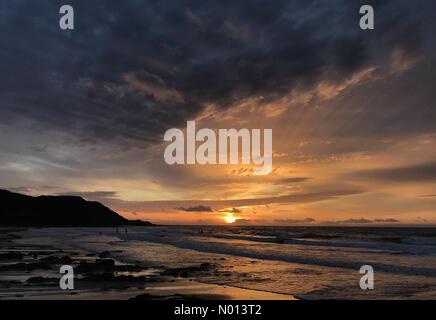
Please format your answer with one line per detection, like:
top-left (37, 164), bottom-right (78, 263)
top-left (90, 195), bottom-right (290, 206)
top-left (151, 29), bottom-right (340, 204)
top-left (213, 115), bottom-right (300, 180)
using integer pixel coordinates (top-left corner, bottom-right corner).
top-left (0, 0), bottom-right (431, 147)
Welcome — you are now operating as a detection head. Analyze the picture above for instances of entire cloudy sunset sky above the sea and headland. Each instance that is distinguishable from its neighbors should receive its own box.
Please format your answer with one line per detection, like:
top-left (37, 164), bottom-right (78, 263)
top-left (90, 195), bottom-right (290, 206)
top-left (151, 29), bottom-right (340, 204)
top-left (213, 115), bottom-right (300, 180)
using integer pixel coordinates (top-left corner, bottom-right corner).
top-left (0, 0), bottom-right (436, 226)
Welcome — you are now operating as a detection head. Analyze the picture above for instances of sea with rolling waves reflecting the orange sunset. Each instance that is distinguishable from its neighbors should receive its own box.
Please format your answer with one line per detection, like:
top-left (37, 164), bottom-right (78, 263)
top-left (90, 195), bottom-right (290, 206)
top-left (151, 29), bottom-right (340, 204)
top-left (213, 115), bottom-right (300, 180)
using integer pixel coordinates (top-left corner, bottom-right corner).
top-left (21, 226), bottom-right (436, 300)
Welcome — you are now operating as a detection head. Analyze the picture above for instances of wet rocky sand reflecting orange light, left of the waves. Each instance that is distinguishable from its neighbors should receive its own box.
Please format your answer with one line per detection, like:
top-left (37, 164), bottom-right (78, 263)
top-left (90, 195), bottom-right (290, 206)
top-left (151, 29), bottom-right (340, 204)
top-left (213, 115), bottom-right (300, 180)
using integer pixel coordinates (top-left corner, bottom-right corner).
top-left (0, 229), bottom-right (294, 300)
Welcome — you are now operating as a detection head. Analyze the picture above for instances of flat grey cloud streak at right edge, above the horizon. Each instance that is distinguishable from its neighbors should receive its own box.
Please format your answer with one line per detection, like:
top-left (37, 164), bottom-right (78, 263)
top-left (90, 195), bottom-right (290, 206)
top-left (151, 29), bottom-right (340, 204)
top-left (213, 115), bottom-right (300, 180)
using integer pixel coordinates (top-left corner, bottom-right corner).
top-left (353, 162), bottom-right (436, 183)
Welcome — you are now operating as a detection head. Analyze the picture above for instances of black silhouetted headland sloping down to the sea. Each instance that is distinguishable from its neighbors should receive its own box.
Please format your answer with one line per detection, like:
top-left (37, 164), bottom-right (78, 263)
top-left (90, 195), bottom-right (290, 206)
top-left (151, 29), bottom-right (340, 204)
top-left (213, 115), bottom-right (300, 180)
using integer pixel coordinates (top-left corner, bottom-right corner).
top-left (0, 190), bottom-right (152, 227)
